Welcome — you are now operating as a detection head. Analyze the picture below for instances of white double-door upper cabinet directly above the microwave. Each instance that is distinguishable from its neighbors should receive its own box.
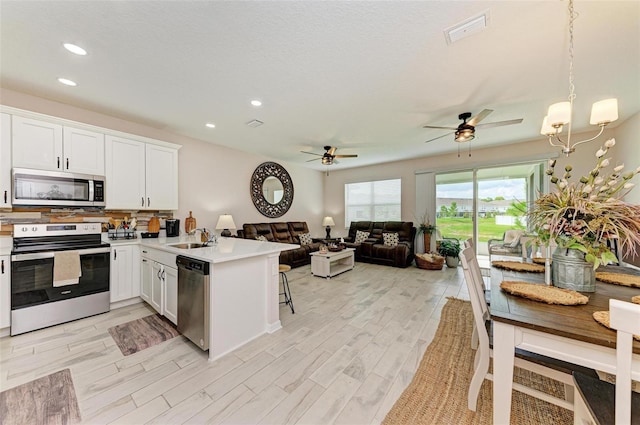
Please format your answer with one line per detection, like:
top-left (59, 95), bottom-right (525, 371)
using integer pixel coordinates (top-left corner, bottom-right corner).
top-left (12, 115), bottom-right (104, 175)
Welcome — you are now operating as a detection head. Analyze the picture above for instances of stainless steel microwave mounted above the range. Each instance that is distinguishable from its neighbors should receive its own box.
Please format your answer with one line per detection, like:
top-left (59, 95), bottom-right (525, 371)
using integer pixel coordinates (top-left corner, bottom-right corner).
top-left (12, 168), bottom-right (105, 207)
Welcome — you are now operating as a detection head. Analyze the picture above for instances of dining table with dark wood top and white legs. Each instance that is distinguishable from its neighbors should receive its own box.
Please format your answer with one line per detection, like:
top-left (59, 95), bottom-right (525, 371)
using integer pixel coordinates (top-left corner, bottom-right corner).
top-left (490, 266), bottom-right (640, 425)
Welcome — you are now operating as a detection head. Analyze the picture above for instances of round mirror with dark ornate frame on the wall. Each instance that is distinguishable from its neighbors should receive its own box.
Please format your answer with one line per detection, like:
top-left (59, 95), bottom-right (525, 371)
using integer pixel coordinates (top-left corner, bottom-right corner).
top-left (251, 162), bottom-right (293, 218)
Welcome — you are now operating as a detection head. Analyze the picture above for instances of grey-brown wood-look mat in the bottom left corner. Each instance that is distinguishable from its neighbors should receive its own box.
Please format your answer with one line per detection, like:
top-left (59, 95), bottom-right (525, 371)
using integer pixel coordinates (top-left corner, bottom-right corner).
top-left (0, 369), bottom-right (81, 425)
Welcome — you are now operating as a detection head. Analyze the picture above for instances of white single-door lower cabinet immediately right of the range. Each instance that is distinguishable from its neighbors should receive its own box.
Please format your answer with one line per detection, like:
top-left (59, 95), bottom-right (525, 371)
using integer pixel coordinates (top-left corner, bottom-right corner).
top-left (110, 245), bottom-right (140, 303)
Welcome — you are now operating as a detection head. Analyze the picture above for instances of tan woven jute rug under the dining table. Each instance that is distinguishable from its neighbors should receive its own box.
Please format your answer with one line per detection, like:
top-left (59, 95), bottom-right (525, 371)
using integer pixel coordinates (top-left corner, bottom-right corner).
top-left (383, 298), bottom-right (573, 425)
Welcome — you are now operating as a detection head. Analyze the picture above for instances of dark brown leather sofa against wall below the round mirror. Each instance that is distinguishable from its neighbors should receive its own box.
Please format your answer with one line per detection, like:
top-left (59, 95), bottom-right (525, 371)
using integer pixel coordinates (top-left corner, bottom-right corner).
top-left (237, 221), bottom-right (322, 267)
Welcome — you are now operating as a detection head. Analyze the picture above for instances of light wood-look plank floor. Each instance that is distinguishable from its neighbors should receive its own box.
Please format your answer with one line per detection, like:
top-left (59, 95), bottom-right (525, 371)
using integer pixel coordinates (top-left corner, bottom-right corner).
top-left (0, 263), bottom-right (469, 425)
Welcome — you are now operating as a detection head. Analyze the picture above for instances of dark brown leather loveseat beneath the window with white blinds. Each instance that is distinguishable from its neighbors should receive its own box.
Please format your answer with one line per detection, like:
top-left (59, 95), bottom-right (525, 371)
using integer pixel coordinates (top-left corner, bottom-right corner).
top-left (344, 221), bottom-right (416, 268)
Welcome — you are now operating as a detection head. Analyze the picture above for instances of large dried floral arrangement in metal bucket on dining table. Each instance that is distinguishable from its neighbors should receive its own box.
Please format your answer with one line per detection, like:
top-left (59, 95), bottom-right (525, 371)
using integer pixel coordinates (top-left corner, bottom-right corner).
top-left (528, 139), bottom-right (640, 269)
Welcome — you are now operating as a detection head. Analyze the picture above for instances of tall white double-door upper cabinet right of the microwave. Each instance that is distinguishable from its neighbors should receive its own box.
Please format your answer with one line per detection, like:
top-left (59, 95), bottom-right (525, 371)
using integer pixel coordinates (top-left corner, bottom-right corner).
top-left (105, 136), bottom-right (178, 210)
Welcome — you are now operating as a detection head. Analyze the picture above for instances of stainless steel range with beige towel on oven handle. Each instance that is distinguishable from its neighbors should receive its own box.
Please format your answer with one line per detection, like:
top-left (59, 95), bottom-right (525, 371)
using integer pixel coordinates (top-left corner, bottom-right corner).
top-left (11, 223), bottom-right (110, 335)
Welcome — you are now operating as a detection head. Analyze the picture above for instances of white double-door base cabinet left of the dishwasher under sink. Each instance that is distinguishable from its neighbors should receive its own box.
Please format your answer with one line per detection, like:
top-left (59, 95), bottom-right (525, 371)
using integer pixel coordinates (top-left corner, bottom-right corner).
top-left (140, 247), bottom-right (178, 325)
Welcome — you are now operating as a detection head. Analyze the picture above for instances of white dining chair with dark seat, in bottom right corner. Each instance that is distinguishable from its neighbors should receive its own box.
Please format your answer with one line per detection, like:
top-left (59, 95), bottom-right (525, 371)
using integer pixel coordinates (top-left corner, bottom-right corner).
top-left (573, 299), bottom-right (640, 425)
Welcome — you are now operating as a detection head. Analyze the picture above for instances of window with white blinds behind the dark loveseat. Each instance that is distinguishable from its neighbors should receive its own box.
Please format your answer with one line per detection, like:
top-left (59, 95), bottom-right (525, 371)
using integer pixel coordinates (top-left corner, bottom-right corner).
top-left (344, 179), bottom-right (401, 227)
